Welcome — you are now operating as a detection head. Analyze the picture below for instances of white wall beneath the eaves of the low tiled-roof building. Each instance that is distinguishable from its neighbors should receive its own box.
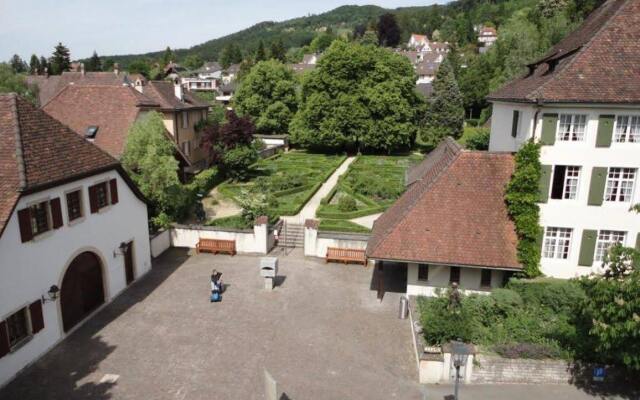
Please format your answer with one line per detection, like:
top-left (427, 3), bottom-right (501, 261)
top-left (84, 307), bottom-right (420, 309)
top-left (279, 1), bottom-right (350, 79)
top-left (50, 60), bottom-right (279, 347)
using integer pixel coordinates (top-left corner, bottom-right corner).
top-left (407, 263), bottom-right (504, 296)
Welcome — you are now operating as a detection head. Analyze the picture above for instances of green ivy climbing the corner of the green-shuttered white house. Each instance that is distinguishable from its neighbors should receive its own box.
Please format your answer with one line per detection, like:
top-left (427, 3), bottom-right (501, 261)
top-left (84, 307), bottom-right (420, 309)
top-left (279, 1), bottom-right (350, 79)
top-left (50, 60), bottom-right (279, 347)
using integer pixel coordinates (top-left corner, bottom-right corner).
top-left (505, 141), bottom-right (542, 278)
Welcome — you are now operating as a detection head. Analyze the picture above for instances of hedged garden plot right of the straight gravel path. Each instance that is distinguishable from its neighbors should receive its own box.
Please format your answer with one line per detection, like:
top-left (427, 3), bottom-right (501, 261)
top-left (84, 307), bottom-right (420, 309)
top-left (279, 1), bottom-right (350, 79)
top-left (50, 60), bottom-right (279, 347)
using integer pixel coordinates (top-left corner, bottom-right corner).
top-left (316, 154), bottom-right (423, 219)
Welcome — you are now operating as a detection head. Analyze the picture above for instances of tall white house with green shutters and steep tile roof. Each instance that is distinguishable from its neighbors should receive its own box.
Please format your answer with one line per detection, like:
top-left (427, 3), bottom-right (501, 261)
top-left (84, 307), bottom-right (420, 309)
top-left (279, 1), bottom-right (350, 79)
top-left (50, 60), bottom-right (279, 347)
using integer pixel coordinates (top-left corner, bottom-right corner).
top-left (489, 0), bottom-right (640, 278)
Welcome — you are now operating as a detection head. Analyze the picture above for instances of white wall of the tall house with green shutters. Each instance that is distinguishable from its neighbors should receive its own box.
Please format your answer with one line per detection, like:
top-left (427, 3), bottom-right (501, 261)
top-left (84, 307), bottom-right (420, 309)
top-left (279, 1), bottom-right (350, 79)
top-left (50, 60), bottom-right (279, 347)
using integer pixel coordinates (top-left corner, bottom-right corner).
top-left (489, 102), bottom-right (640, 278)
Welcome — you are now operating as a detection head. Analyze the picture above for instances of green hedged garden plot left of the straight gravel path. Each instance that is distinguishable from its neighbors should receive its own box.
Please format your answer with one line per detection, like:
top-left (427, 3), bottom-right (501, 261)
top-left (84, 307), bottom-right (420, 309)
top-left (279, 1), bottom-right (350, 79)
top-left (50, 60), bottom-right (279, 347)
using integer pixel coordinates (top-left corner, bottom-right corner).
top-left (218, 151), bottom-right (345, 215)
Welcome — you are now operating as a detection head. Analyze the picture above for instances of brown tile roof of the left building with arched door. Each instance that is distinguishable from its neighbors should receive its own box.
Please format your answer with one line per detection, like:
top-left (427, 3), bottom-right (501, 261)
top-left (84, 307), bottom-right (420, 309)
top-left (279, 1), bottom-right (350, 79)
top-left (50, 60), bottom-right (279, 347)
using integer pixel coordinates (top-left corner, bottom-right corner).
top-left (0, 93), bottom-right (130, 238)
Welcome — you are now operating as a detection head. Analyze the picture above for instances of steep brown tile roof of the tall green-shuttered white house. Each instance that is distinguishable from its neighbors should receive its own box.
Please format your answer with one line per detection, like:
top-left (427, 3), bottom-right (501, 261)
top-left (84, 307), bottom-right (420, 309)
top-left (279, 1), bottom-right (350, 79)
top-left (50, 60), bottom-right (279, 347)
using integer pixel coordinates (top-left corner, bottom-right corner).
top-left (488, 0), bottom-right (640, 104)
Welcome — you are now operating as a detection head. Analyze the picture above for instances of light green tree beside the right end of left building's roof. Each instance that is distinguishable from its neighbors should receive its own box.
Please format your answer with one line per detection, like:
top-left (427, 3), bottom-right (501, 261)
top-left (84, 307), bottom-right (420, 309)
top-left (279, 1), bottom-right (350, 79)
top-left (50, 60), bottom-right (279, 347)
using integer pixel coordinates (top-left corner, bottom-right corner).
top-left (122, 111), bottom-right (186, 223)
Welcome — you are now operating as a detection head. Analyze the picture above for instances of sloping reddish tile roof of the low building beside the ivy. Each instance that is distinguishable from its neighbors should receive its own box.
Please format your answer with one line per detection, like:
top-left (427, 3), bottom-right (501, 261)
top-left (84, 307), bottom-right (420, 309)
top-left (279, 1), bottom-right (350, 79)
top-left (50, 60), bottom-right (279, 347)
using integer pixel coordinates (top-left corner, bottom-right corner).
top-left (367, 142), bottom-right (521, 270)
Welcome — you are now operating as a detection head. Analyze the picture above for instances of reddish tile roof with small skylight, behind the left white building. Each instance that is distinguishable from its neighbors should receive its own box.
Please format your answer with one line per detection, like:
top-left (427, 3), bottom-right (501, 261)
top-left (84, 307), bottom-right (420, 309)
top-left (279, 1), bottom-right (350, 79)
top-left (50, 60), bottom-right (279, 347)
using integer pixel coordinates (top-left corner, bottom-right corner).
top-left (43, 85), bottom-right (159, 158)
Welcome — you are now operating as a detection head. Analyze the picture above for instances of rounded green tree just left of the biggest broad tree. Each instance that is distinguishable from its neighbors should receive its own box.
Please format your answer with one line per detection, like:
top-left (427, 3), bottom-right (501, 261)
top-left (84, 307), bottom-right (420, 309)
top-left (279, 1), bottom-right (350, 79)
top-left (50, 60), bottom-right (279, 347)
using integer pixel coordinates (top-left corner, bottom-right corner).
top-left (235, 60), bottom-right (297, 134)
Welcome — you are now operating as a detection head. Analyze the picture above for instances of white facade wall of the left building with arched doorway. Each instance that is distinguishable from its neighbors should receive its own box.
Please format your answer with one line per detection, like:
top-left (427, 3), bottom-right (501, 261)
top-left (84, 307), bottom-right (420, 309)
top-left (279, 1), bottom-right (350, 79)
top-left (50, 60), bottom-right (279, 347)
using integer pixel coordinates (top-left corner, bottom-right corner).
top-left (0, 171), bottom-right (151, 386)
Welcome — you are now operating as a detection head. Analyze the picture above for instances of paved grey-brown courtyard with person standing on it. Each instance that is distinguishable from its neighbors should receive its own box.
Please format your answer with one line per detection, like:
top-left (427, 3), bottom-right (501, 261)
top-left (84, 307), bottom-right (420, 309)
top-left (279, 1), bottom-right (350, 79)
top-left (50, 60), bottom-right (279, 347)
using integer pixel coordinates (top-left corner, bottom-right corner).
top-left (0, 249), bottom-right (422, 400)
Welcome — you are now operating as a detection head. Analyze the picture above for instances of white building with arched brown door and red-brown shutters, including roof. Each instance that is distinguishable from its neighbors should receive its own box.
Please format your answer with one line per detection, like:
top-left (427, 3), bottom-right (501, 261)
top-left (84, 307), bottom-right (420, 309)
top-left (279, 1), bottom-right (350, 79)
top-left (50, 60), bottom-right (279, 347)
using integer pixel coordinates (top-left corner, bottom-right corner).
top-left (0, 94), bottom-right (151, 386)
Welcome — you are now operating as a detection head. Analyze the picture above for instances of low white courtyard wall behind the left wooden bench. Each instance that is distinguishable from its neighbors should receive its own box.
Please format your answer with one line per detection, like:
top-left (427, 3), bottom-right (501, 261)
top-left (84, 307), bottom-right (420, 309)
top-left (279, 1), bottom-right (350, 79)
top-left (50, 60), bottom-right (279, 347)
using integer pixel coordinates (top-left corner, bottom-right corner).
top-left (171, 220), bottom-right (275, 254)
